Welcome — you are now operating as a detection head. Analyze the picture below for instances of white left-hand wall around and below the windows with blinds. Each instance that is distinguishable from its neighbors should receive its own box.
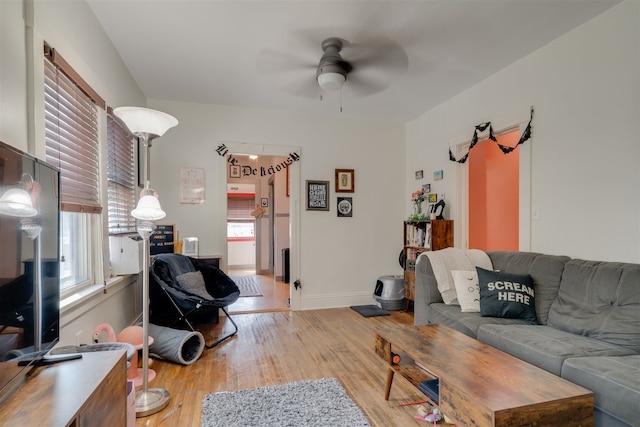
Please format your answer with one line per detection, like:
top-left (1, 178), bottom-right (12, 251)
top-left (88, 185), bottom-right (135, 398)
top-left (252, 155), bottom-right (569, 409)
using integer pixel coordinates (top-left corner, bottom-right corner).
top-left (0, 0), bottom-right (146, 345)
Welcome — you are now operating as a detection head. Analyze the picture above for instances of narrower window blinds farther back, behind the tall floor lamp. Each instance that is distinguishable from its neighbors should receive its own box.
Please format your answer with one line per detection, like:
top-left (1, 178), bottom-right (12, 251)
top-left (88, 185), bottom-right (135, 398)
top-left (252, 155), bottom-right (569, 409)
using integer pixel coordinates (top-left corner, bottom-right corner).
top-left (107, 114), bottom-right (136, 234)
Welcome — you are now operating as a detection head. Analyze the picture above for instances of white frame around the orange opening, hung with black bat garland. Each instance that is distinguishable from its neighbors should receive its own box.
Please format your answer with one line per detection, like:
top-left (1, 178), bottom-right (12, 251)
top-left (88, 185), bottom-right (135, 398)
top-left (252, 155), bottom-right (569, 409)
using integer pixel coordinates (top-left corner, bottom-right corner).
top-left (449, 122), bottom-right (533, 252)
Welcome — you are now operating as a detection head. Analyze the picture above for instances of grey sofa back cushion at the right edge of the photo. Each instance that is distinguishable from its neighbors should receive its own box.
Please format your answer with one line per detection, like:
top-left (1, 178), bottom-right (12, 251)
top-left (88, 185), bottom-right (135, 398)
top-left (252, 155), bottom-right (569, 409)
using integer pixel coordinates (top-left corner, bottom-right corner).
top-left (549, 259), bottom-right (640, 353)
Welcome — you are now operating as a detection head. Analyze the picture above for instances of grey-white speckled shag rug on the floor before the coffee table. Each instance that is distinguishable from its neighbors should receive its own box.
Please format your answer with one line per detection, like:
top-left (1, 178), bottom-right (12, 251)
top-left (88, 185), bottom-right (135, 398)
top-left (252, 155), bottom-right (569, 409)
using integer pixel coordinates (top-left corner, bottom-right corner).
top-left (200, 378), bottom-right (370, 427)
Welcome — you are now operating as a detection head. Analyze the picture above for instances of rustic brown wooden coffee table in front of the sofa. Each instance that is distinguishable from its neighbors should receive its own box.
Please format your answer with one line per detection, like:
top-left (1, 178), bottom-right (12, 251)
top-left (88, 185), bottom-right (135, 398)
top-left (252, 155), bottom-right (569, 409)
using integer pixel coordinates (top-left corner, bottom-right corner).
top-left (375, 325), bottom-right (593, 427)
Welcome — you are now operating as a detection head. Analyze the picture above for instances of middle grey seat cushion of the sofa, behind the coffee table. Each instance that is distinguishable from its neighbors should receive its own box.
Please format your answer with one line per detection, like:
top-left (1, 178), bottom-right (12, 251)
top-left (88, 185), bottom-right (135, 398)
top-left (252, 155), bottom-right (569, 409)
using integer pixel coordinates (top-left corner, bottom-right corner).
top-left (478, 324), bottom-right (634, 375)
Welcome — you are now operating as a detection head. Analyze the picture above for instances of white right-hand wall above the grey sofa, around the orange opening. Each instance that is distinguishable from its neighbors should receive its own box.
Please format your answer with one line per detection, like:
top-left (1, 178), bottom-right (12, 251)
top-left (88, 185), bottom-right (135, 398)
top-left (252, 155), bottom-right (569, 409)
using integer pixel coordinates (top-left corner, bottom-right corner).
top-left (405, 1), bottom-right (640, 262)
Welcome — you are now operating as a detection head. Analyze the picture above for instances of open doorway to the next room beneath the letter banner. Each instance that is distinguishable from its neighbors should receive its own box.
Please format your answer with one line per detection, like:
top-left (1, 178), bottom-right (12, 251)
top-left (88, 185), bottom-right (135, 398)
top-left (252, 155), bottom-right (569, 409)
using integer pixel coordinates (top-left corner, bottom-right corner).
top-left (227, 154), bottom-right (291, 314)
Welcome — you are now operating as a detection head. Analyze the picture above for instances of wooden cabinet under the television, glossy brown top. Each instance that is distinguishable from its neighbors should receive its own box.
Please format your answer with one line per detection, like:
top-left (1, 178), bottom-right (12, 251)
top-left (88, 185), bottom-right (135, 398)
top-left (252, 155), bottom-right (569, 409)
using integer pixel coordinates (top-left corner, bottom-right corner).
top-left (0, 350), bottom-right (127, 427)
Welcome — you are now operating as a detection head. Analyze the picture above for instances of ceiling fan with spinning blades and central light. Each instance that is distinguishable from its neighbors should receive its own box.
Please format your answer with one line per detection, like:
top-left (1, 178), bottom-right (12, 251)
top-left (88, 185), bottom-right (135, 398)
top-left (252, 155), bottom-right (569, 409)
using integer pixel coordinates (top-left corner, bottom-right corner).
top-left (258, 37), bottom-right (409, 98)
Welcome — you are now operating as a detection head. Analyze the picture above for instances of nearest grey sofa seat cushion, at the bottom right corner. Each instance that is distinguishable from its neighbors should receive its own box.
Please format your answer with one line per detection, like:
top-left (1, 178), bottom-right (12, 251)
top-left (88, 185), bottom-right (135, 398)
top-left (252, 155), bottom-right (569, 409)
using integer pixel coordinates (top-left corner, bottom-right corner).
top-left (561, 355), bottom-right (640, 426)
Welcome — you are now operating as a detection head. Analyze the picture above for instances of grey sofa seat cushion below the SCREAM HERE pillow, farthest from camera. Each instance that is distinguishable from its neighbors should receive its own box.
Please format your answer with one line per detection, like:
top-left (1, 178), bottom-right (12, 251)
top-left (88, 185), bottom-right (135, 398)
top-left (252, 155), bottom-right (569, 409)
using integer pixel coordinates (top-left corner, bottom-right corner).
top-left (428, 303), bottom-right (529, 338)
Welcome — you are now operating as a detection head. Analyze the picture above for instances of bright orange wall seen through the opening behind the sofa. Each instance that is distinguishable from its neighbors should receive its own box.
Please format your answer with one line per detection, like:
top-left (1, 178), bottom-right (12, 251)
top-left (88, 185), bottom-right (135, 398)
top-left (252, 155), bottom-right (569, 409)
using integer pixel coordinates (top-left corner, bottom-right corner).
top-left (469, 131), bottom-right (520, 251)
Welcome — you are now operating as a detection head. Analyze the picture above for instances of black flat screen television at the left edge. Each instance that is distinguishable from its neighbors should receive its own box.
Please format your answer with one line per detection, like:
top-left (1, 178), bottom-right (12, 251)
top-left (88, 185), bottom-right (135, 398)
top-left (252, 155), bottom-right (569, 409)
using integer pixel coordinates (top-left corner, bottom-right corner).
top-left (0, 142), bottom-right (60, 402)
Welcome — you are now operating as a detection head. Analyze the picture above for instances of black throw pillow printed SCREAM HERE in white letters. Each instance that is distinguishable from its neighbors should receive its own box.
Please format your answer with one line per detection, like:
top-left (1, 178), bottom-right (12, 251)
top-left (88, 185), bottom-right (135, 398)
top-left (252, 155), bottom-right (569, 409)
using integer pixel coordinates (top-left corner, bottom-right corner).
top-left (476, 267), bottom-right (537, 323)
